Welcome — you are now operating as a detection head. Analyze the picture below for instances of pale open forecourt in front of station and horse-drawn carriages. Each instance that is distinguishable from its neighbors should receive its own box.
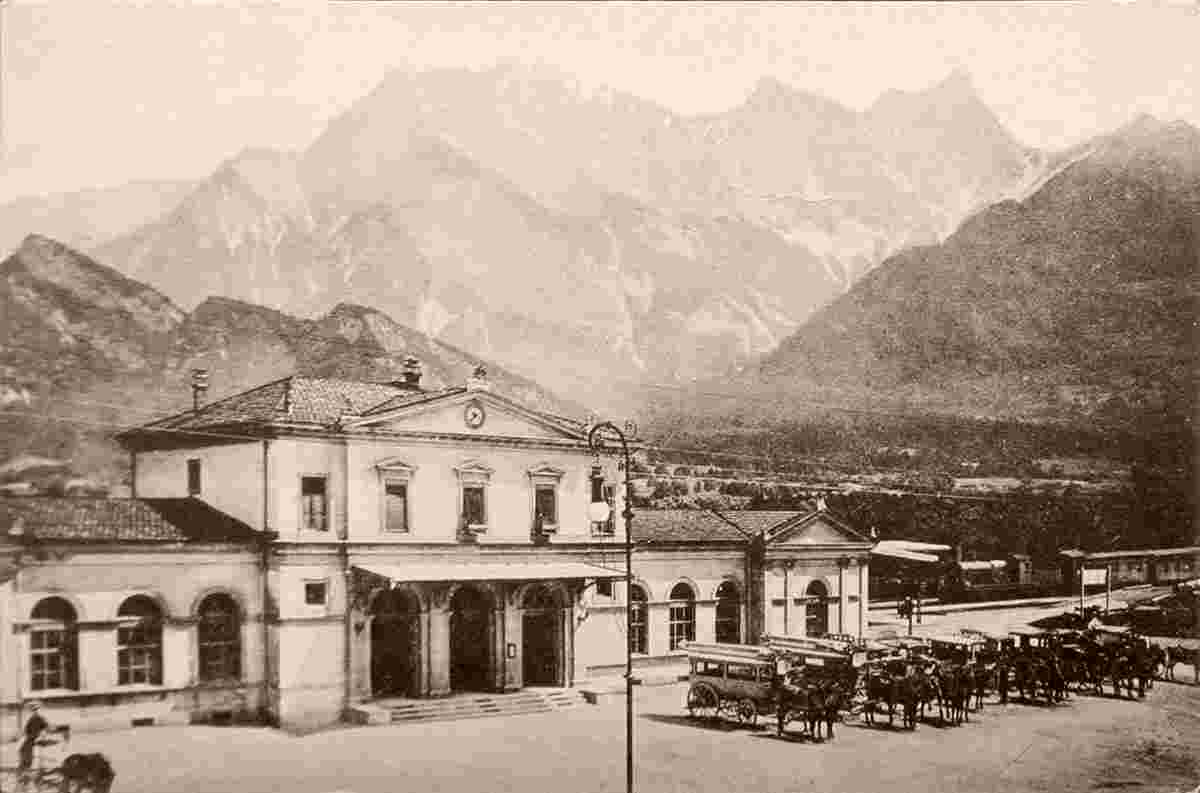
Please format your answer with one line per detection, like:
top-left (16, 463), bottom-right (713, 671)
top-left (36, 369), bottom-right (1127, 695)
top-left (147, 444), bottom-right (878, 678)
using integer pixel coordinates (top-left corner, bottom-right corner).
top-left (5, 683), bottom-right (1200, 793)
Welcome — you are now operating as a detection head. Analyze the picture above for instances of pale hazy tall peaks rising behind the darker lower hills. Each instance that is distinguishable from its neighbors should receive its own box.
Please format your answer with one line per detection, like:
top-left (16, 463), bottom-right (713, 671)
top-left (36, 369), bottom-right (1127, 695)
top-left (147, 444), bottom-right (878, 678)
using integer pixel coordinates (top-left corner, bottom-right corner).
top-left (2, 65), bottom-right (1052, 398)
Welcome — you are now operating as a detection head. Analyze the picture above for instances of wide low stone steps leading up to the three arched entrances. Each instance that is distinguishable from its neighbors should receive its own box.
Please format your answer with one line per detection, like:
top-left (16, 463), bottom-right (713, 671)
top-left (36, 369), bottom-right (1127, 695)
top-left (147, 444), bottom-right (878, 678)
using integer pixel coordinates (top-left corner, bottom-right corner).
top-left (356, 689), bottom-right (587, 725)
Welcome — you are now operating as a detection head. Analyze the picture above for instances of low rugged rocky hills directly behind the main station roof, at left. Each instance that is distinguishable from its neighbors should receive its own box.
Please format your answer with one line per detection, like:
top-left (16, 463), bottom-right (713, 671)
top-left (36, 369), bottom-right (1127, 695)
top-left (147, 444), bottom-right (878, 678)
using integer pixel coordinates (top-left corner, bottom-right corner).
top-left (0, 235), bottom-right (571, 482)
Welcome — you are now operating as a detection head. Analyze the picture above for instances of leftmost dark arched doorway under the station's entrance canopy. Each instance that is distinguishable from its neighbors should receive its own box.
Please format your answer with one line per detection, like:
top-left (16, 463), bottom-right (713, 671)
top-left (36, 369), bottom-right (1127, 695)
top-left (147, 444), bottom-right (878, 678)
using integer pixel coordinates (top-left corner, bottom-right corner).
top-left (371, 589), bottom-right (421, 697)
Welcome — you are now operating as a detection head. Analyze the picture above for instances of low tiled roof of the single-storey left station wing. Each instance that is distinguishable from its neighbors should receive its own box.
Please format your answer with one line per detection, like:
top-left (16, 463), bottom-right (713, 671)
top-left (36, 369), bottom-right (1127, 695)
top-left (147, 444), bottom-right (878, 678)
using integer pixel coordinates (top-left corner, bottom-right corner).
top-left (0, 497), bottom-right (259, 542)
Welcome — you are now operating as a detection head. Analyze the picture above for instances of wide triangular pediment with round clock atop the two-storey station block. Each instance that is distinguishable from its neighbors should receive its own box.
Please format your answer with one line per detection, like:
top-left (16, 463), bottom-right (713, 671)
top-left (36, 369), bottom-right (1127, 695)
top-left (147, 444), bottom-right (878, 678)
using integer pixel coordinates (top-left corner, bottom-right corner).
top-left (347, 391), bottom-right (584, 440)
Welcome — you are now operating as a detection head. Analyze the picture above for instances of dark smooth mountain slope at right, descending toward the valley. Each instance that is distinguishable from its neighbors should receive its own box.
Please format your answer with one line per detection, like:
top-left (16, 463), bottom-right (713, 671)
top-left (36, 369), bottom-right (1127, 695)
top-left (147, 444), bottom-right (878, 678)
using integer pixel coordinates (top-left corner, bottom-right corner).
top-left (745, 112), bottom-right (1200, 426)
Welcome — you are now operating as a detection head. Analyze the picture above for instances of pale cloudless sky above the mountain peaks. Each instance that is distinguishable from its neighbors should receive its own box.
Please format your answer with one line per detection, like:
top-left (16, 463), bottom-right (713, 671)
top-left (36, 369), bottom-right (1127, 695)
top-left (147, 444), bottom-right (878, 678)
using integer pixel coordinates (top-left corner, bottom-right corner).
top-left (0, 0), bottom-right (1200, 202)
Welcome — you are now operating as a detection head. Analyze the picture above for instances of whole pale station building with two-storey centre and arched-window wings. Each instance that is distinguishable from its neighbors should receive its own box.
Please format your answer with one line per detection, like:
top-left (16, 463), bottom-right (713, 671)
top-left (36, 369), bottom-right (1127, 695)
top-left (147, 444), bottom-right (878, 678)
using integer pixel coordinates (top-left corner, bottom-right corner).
top-left (0, 360), bottom-right (872, 734)
